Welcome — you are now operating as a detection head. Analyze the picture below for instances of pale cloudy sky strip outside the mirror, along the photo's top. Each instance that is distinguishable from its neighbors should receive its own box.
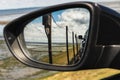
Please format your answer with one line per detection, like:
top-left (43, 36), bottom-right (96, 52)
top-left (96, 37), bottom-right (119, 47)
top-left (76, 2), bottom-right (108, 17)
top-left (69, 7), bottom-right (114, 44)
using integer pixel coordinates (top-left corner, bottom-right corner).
top-left (0, 0), bottom-right (119, 10)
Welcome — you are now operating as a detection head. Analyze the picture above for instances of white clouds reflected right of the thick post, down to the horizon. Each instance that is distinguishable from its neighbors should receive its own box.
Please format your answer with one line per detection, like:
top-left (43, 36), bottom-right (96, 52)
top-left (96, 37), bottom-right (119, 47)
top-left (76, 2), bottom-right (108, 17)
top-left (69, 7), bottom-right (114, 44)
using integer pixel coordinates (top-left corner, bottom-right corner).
top-left (52, 8), bottom-right (90, 42)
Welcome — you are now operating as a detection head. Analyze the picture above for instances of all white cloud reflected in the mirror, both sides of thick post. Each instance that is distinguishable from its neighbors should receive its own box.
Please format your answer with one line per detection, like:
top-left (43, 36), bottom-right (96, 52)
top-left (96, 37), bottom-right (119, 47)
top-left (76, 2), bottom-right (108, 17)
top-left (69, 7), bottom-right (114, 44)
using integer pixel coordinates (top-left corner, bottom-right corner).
top-left (25, 8), bottom-right (90, 42)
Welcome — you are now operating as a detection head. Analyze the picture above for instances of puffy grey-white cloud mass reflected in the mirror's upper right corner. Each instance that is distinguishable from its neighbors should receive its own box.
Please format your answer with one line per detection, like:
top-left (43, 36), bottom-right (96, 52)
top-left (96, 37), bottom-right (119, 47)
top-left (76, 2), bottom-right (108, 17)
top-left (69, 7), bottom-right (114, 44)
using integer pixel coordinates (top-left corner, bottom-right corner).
top-left (54, 8), bottom-right (90, 35)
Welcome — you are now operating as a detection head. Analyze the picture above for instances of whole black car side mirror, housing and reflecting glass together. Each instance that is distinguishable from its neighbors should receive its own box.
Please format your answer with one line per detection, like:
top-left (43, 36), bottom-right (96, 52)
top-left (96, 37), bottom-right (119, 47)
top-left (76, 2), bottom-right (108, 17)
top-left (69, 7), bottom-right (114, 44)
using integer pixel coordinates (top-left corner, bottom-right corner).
top-left (4, 2), bottom-right (120, 71)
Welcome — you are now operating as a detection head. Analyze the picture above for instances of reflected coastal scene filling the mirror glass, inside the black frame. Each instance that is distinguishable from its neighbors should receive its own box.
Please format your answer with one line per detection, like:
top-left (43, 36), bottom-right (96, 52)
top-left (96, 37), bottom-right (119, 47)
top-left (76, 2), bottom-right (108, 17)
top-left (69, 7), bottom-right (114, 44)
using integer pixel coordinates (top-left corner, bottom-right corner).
top-left (24, 8), bottom-right (90, 65)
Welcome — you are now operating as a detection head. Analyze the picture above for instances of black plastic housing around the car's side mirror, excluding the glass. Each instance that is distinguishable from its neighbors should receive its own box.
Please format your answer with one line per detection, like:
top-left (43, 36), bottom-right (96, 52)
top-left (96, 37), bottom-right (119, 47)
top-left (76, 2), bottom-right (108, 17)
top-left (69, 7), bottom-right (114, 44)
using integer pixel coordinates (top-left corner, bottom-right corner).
top-left (4, 2), bottom-right (120, 71)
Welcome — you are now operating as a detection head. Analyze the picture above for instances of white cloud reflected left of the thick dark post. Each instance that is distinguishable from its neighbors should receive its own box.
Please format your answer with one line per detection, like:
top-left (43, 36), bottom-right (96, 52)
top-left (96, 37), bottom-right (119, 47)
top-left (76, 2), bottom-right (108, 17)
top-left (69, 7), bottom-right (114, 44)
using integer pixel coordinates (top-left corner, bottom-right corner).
top-left (24, 23), bottom-right (47, 42)
